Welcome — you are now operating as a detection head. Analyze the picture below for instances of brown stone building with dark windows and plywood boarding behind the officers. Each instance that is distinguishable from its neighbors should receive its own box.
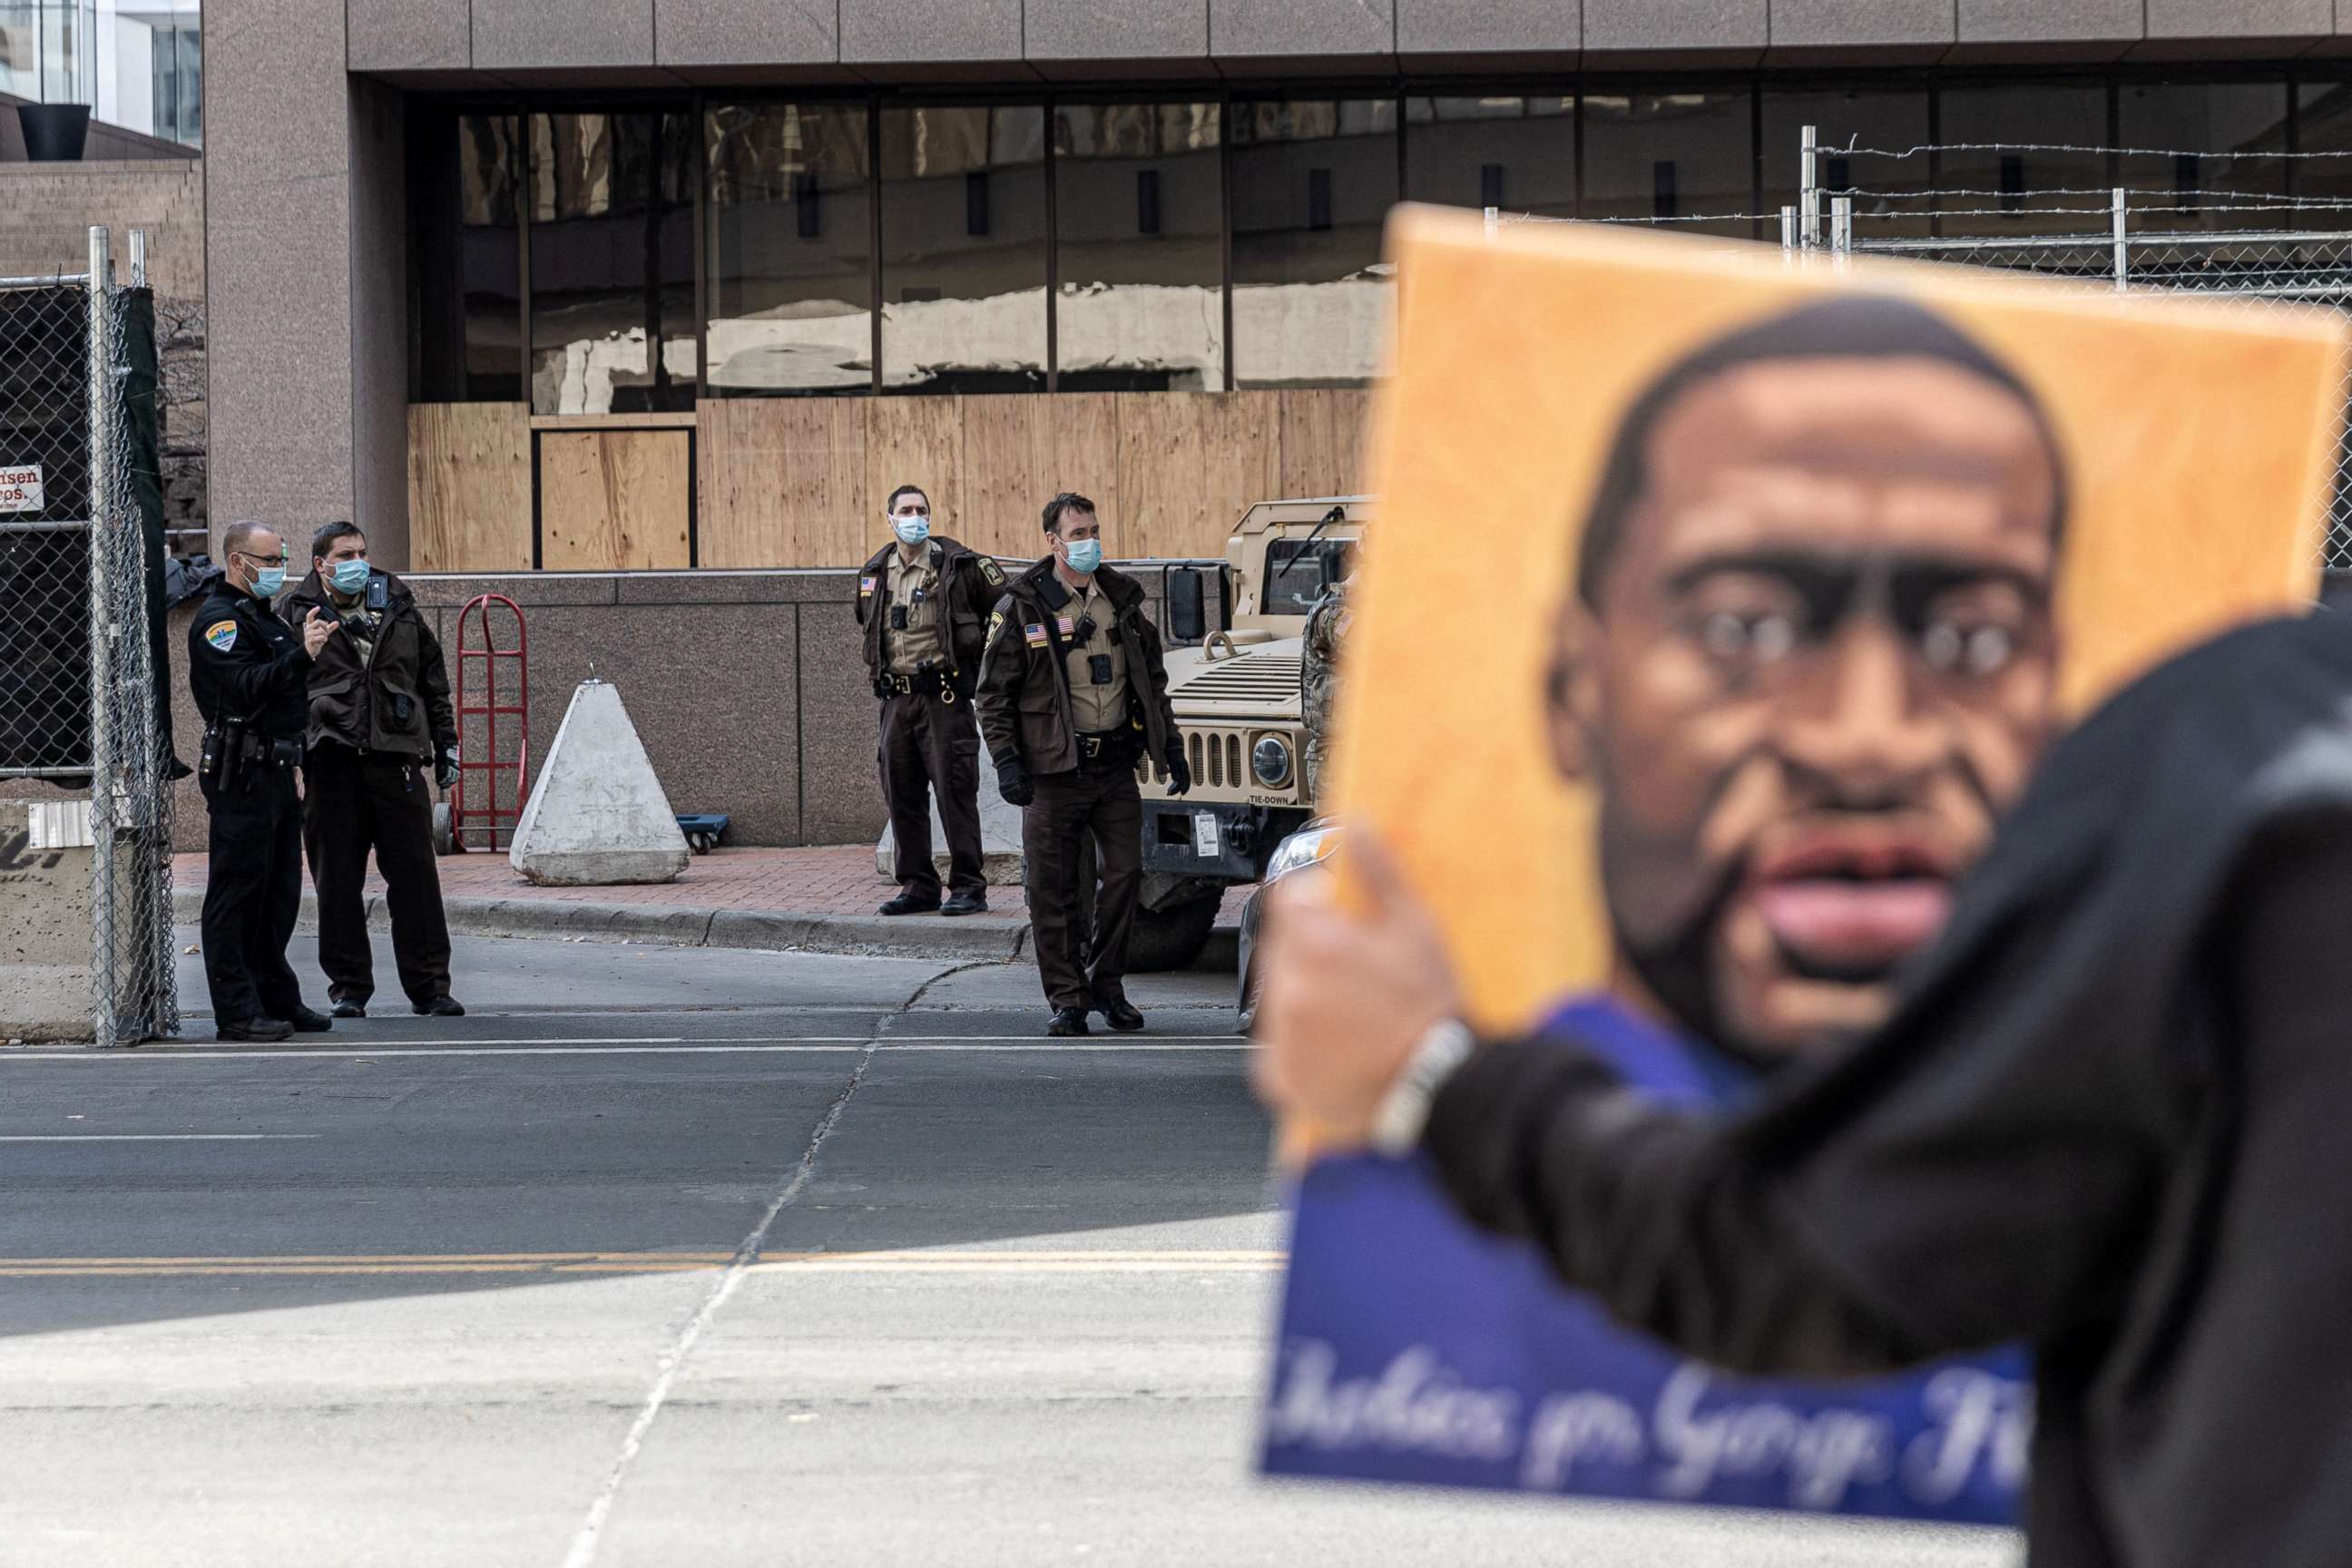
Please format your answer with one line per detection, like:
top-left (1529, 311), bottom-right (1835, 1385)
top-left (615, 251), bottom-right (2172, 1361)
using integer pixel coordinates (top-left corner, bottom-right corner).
top-left (173, 0), bottom-right (2352, 841)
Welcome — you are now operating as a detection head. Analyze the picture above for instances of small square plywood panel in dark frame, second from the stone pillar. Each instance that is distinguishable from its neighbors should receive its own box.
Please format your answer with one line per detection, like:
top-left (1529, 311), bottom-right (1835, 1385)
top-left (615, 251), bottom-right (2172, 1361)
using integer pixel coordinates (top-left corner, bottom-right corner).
top-left (539, 430), bottom-right (694, 572)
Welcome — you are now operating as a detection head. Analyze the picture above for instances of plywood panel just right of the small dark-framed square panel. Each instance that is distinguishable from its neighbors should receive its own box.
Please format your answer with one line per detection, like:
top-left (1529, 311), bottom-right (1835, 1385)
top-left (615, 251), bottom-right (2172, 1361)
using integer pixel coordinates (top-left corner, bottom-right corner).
top-left (701, 397), bottom-right (882, 566)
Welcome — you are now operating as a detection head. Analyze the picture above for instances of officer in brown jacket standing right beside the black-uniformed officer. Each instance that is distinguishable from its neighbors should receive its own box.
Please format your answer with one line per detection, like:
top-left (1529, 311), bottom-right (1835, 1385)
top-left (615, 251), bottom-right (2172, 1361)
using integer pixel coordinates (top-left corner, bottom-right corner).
top-left (287, 522), bottom-right (466, 1018)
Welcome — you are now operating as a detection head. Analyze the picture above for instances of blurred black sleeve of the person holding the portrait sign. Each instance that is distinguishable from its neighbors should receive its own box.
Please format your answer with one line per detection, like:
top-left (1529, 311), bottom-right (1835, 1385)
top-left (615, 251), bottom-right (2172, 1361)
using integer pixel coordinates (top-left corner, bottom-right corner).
top-left (1426, 681), bottom-right (2230, 1376)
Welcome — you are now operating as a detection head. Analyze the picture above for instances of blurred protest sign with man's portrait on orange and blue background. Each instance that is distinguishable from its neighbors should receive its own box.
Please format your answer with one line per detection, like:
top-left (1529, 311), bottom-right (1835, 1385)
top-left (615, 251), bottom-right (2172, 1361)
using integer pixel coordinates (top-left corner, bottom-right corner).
top-left (1265, 210), bottom-right (2343, 1524)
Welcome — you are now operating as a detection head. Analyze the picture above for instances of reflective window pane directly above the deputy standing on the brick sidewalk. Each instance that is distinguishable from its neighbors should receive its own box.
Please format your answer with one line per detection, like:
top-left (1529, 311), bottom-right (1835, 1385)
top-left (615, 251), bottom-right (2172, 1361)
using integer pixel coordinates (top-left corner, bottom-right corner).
top-left (882, 103), bottom-right (1046, 393)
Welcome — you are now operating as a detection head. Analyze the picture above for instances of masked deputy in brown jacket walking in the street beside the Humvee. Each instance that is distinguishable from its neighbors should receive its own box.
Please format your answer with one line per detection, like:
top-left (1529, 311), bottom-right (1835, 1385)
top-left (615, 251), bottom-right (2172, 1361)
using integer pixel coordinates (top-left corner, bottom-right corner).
top-left (981, 491), bottom-right (1192, 1037)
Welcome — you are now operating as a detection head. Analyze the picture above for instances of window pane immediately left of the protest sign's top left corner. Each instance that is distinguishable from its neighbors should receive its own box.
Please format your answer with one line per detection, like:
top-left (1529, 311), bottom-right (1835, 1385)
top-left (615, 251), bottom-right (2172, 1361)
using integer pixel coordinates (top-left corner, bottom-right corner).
top-left (1232, 99), bottom-right (1399, 386)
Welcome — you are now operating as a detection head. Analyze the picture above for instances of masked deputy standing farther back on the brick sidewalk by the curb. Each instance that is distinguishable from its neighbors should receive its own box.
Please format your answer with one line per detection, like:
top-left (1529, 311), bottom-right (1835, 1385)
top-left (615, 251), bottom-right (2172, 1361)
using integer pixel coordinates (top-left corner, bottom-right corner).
top-left (858, 485), bottom-right (1004, 915)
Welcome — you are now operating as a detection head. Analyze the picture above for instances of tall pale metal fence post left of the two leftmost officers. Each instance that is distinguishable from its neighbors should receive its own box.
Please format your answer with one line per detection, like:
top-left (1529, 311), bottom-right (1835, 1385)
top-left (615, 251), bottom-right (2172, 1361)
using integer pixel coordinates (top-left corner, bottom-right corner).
top-left (84, 228), bottom-right (122, 1051)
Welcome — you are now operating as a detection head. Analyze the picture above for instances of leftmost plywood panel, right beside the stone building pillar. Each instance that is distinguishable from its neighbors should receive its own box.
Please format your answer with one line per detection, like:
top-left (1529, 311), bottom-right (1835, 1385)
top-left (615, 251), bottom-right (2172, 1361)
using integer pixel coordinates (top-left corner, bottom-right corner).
top-left (409, 402), bottom-right (532, 572)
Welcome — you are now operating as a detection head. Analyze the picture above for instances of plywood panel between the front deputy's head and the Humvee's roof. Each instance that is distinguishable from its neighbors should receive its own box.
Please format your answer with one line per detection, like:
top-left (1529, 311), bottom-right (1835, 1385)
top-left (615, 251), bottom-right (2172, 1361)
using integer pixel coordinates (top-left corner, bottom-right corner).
top-left (1117, 393), bottom-right (1282, 557)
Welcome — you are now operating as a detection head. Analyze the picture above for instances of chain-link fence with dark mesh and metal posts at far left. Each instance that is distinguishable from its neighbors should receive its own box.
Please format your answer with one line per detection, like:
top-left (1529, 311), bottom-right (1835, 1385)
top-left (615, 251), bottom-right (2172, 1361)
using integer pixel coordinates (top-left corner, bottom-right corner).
top-left (0, 228), bottom-right (179, 1046)
